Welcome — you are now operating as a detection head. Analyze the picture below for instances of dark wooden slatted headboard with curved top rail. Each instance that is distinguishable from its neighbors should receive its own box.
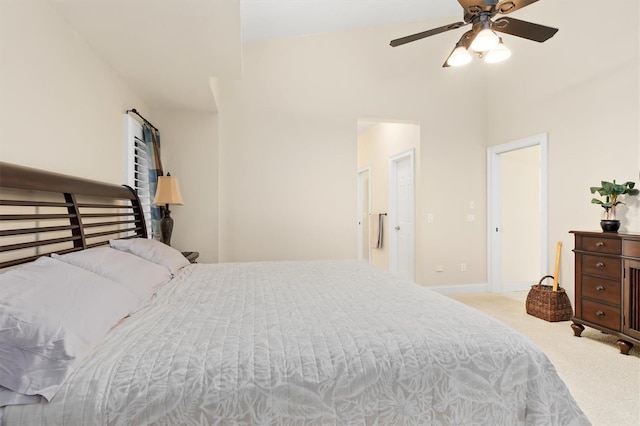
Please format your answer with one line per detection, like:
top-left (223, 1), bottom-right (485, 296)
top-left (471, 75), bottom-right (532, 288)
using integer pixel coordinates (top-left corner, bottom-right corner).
top-left (0, 162), bottom-right (147, 268)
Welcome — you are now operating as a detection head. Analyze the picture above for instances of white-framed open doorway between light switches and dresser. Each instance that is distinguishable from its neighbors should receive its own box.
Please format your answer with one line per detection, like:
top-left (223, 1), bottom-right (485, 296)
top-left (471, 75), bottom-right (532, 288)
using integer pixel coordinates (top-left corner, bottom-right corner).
top-left (487, 134), bottom-right (548, 293)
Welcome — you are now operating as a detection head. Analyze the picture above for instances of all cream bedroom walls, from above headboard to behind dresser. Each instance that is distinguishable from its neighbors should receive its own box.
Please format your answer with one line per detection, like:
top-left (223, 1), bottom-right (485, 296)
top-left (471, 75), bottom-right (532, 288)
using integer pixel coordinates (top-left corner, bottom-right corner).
top-left (5, 0), bottom-right (640, 294)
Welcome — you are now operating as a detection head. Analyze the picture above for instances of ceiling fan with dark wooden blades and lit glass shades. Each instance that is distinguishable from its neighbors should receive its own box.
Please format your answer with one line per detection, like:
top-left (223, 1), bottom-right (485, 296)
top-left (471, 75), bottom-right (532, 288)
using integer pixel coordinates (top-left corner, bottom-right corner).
top-left (390, 0), bottom-right (558, 67)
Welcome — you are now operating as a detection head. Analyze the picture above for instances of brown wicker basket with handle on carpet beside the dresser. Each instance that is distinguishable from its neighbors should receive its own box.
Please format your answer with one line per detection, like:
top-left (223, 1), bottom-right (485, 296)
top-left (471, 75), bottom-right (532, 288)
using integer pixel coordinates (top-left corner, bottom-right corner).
top-left (526, 275), bottom-right (573, 322)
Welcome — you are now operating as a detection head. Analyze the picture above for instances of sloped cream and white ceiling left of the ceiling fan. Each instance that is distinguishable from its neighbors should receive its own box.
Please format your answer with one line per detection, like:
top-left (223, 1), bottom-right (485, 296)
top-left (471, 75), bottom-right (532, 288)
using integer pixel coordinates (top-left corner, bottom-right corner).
top-left (48, 0), bottom-right (462, 111)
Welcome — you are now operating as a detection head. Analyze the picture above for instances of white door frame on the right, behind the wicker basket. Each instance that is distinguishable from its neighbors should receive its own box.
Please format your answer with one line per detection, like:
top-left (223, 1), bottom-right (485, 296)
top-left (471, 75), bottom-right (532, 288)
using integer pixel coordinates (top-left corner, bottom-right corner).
top-left (487, 133), bottom-right (549, 293)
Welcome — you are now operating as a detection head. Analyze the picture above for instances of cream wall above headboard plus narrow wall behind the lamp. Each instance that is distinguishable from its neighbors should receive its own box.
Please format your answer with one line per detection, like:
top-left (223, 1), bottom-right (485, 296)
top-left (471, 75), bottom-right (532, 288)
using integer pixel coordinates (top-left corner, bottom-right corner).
top-left (0, 0), bottom-right (218, 262)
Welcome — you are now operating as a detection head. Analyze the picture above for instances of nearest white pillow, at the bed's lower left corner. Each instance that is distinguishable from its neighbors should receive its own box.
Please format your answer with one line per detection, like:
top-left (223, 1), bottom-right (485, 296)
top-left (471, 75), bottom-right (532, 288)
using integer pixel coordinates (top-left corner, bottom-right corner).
top-left (0, 257), bottom-right (139, 400)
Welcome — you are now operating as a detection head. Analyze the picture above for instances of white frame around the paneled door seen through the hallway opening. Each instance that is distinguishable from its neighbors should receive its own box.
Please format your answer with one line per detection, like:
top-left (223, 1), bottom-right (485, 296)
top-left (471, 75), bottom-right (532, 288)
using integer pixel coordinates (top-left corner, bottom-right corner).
top-left (387, 148), bottom-right (416, 281)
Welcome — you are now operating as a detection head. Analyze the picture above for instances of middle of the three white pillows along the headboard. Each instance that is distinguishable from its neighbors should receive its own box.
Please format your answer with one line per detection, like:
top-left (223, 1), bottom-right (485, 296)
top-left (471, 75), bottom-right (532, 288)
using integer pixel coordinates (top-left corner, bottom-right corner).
top-left (51, 246), bottom-right (171, 307)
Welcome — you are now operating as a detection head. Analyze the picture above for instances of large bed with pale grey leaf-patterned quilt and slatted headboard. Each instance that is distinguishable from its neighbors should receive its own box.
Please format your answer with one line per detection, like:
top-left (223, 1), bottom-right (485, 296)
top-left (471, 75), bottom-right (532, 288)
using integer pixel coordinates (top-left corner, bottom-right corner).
top-left (0, 163), bottom-right (589, 426)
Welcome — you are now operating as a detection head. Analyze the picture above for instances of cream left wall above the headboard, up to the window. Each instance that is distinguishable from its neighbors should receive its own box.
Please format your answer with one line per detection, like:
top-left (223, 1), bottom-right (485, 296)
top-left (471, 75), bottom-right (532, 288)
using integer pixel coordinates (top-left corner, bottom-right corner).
top-left (0, 0), bottom-right (147, 183)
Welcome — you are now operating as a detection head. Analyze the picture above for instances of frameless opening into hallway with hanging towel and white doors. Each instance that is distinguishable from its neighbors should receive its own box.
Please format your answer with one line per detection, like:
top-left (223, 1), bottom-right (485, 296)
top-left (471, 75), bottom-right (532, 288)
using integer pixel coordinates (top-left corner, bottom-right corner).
top-left (357, 120), bottom-right (420, 280)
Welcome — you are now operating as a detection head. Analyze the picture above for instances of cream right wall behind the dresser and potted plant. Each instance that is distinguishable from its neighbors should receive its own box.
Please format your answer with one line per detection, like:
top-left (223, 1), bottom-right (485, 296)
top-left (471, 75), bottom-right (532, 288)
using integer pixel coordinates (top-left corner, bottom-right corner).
top-left (488, 0), bottom-right (640, 300)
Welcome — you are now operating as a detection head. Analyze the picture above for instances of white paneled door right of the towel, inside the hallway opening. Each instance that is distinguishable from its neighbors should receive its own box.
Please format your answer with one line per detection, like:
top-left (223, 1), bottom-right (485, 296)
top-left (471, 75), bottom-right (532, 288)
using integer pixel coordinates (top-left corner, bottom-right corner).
top-left (388, 150), bottom-right (415, 281)
